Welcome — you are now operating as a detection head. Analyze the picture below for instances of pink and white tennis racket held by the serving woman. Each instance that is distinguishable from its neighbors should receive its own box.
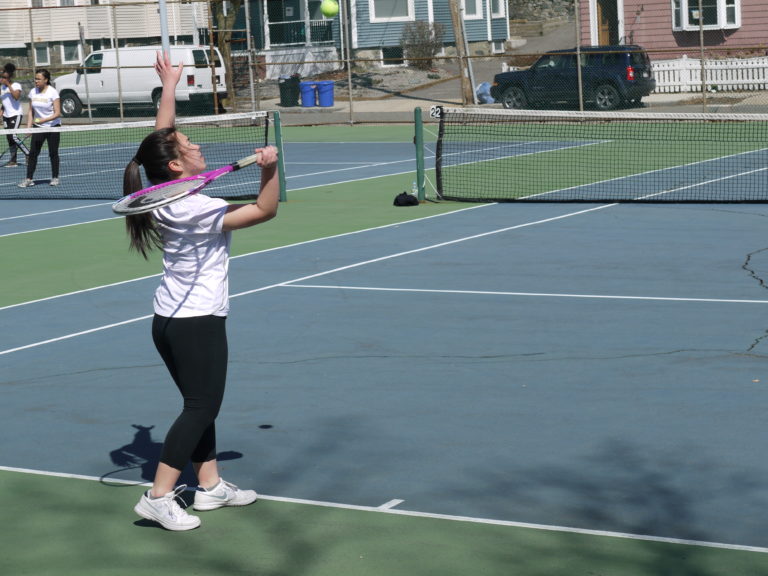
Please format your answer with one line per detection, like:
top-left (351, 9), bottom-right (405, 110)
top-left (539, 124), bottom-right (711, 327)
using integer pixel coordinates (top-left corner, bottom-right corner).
top-left (112, 153), bottom-right (261, 215)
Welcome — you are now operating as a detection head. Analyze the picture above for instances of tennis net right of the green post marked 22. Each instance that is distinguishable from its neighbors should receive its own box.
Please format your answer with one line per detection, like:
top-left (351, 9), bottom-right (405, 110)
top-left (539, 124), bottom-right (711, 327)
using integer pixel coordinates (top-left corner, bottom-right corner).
top-left (436, 108), bottom-right (768, 202)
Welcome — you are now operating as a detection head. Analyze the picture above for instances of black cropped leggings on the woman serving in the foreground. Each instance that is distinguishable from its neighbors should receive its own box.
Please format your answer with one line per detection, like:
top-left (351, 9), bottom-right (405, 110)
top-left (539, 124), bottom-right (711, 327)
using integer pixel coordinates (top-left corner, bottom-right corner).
top-left (152, 315), bottom-right (228, 470)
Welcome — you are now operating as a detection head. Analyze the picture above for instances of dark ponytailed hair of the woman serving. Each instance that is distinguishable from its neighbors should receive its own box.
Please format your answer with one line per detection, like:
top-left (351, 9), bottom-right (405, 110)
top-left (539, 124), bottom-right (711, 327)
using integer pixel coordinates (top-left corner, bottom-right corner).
top-left (123, 128), bottom-right (179, 259)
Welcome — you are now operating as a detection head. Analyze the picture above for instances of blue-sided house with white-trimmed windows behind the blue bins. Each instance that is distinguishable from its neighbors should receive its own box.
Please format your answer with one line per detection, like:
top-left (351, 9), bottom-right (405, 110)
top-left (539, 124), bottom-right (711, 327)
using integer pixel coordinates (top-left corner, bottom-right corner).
top-left (243, 0), bottom-right (509, 77)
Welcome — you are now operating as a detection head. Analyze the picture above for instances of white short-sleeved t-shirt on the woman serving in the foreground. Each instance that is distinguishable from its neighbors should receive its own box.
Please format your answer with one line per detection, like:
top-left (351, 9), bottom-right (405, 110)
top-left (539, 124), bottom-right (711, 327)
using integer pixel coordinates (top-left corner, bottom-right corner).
top-left (154, 194), bottom-right (232, 318)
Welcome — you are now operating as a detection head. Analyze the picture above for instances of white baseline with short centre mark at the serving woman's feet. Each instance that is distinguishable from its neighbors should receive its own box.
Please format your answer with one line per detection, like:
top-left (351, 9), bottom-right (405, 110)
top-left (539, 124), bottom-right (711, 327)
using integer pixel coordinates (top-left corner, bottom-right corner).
top-left (0, 466), bottom-right (768, 554)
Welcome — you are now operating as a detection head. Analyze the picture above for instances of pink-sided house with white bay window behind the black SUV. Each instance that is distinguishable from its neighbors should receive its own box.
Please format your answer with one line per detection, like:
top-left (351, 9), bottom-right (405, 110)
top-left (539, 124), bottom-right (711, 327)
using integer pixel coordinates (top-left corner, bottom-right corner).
top-left (579, 0), bottom-right (768, 55)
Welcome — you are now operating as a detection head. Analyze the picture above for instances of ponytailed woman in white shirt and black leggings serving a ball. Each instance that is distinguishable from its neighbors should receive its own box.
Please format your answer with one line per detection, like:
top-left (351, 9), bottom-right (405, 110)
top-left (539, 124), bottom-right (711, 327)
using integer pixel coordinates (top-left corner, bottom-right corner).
top-left (123, 54), bottom-right (279, 530)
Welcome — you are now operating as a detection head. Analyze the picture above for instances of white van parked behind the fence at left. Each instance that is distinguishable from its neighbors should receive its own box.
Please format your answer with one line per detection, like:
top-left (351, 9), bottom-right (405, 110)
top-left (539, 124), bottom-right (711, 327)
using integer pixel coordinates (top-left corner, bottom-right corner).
top-left (53, 45), bottom-right (227, 117)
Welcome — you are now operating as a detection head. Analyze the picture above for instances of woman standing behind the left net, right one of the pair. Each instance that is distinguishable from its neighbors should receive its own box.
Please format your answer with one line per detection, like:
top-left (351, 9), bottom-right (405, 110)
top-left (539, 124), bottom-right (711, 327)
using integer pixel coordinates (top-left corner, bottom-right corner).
top-left (18, 68), bottom-right (61, 188)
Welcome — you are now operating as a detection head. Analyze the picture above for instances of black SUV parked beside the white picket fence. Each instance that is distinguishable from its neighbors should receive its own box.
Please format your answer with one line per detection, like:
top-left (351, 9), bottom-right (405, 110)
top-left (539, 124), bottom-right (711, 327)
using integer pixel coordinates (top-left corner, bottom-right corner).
top-left (491, 46), bottom-right (656, 110)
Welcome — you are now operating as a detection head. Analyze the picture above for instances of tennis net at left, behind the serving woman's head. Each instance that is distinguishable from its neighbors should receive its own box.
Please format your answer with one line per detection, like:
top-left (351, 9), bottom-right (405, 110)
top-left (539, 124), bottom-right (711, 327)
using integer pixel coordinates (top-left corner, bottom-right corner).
top-left (0, 112), bottom-right (269, 200)
